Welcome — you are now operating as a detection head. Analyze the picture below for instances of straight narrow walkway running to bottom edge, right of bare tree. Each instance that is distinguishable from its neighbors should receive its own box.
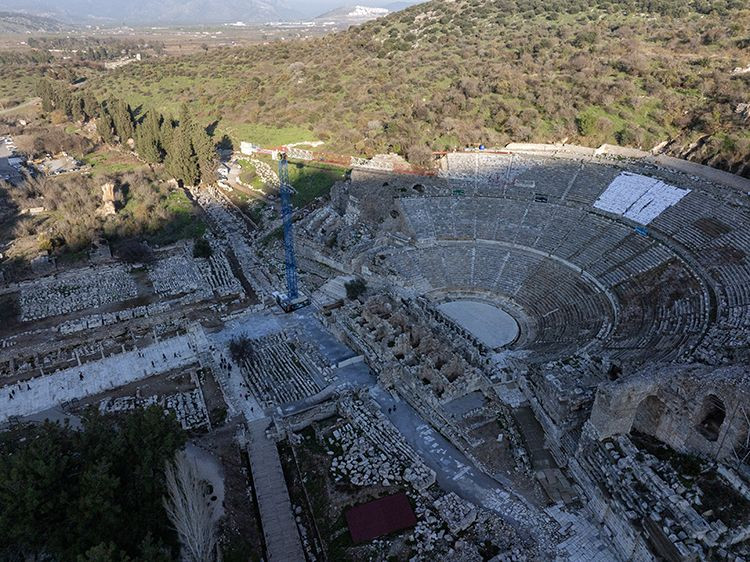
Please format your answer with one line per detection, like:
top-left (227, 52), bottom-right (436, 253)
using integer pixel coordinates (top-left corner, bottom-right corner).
top-left (247, 418), bottom-right (305, 562)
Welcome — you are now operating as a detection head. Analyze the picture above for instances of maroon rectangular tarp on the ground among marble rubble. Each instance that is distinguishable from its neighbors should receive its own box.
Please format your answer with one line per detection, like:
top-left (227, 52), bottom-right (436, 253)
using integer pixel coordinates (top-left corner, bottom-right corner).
top-left (345, 492), bottom-right (417, 543)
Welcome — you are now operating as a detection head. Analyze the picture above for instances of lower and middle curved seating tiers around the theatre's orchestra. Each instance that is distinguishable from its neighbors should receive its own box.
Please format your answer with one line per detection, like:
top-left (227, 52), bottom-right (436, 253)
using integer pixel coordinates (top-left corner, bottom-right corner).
top-left (379, 184), bottom-right (732, 359)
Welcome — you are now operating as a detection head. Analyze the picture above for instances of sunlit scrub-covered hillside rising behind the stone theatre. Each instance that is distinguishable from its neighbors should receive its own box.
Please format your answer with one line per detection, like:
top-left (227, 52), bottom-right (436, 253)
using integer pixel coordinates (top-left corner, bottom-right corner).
top-left (88, 0), bottom-right (750, 175)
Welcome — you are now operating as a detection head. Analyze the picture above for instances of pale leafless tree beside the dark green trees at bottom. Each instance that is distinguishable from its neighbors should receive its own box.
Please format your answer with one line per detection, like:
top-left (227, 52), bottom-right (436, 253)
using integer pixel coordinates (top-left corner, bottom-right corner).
top-left (164, 451), bottom-right (217, 562)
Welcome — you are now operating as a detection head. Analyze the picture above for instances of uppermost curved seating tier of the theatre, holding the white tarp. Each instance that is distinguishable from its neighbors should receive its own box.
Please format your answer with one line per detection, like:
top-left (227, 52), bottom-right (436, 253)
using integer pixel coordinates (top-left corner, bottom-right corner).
top-left (434, 152), bottom-right (750, 362)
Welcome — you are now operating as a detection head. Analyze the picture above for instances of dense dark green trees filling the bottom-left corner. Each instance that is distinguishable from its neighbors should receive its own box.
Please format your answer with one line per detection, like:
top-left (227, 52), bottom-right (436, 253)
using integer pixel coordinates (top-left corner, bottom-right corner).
top-left (0, 406), bottom-right (184, 562)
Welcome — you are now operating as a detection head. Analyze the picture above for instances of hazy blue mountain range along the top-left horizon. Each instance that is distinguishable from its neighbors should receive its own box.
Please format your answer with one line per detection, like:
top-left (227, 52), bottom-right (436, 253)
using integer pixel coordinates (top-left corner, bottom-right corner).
top-left (2, 0), bottom-right (289, 25)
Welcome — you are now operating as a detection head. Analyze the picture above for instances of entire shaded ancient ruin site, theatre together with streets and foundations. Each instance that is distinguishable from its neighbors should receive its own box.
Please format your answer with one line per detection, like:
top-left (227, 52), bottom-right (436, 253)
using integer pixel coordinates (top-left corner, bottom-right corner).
top-left (0, 145), bottom-right (750, 561)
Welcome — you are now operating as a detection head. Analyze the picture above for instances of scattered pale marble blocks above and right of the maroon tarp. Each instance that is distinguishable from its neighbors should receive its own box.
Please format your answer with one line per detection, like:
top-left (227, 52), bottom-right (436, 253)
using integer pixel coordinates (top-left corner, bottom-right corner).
top-left (304, 392), bottom-right (538, 562)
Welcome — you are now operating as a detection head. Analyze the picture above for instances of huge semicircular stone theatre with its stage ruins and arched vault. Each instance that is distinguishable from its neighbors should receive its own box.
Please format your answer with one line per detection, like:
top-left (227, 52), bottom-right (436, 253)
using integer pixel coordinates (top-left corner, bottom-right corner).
top-left (290, 147), bottom-right (750, 560)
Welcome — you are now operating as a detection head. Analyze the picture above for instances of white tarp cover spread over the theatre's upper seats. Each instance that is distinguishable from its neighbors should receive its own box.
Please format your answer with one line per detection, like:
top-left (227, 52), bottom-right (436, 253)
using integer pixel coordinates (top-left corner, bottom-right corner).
top-left (594, 172), bottom-right (690, 224)
